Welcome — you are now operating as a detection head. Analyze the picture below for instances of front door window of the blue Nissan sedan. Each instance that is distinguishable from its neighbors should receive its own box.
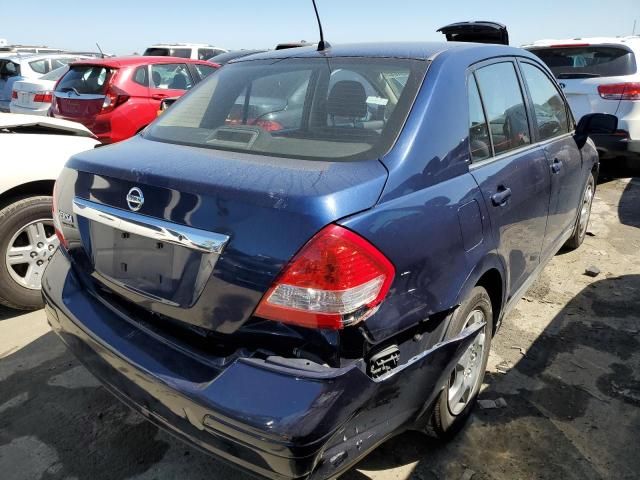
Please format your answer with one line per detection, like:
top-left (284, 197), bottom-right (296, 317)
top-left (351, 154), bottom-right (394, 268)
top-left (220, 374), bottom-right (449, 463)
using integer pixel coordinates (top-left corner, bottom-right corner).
top-left (521, 63), bottom-right (569, 140)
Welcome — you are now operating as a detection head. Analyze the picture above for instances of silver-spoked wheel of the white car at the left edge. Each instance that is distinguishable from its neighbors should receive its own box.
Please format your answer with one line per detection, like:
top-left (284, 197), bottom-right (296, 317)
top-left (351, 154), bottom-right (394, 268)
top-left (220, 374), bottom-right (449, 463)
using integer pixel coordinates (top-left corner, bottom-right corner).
top-left (0, 196), bottom-right (58, 310)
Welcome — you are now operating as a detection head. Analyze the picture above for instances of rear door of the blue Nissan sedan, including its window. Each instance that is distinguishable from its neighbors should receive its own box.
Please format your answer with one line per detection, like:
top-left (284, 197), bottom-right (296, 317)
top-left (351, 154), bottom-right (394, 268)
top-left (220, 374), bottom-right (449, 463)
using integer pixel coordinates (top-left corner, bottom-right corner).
top-left (468, 59), bottom-right (550, 299)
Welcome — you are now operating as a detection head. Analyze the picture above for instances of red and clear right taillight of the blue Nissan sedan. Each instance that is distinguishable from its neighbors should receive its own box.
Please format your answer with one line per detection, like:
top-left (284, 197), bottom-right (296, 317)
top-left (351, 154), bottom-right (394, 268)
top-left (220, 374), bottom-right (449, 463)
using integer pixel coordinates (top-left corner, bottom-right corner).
top-left (255, 225), bottom-right (395, 330)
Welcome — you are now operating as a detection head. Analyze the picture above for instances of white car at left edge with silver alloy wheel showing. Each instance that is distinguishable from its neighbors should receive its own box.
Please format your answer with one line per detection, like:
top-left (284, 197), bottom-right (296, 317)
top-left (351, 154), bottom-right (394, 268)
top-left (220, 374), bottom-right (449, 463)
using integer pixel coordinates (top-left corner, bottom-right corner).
top-left (0, 113), bottom-right (99, 310)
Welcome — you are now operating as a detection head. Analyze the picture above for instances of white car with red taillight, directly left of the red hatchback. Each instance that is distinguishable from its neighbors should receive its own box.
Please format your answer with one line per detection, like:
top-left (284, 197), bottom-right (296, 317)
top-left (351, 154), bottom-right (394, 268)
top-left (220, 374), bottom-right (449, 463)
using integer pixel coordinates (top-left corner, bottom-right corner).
top-left (9, 63), bottom-right (91, 115)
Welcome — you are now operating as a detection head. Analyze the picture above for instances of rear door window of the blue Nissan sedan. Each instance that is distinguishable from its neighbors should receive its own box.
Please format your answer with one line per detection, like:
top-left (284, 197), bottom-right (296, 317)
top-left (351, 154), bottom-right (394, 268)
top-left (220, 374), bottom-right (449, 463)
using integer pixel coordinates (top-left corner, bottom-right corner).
top-left (475, 62), bottom-right (531, 155)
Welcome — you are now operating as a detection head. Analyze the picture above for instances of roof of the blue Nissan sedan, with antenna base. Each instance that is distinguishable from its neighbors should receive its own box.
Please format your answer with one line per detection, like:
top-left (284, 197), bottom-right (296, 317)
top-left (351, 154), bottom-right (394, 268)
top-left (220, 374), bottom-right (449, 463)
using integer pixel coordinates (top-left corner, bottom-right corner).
top-left (229, 42), bottom-right (522, 63)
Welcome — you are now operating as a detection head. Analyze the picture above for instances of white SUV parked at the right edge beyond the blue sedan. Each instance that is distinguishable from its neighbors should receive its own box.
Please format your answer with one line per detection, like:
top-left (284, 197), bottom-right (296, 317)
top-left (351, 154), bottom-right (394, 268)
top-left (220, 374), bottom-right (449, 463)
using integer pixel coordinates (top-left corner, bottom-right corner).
top-left (523, 36), bottom-right (640, 164)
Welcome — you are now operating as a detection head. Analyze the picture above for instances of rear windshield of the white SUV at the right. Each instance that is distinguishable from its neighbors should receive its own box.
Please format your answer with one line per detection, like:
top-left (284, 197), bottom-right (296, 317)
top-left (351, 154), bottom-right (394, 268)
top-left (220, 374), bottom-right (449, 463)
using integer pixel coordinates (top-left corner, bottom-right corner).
top-left (531, 46), bottom-right (636, 78)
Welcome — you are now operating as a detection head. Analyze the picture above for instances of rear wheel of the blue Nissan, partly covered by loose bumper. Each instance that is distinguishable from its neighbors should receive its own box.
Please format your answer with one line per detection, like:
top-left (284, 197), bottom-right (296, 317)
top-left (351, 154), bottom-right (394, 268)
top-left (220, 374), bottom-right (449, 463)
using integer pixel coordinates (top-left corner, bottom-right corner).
top-left (427, 287), bottom-right (493, 440)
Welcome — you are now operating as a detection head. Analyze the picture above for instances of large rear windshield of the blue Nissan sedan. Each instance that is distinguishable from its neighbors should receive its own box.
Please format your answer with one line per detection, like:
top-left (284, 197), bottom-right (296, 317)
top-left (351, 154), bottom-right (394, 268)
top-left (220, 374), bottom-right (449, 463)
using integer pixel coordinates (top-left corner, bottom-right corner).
top-left (145, 58), bottom-right (427, 160)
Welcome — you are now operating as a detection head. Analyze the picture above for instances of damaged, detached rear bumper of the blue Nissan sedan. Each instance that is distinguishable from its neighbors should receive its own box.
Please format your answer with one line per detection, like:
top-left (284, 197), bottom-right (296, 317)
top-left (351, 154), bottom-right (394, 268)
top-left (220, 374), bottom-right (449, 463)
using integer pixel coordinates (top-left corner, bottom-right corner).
top-left (43, 251), bottom-right (479, 480)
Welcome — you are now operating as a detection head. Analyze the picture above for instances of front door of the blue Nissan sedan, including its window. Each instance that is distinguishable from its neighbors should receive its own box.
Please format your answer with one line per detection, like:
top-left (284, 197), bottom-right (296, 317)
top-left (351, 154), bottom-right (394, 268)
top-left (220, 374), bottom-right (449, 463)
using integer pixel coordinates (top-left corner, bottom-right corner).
top-left (518, 60), bottom-right (584, 257)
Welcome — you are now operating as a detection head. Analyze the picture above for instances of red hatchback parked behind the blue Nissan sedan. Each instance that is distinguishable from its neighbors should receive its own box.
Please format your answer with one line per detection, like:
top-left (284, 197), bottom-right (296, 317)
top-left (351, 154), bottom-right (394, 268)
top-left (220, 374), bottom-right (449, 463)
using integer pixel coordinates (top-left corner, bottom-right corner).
top-left (50, 57), bottom-right (218, 143)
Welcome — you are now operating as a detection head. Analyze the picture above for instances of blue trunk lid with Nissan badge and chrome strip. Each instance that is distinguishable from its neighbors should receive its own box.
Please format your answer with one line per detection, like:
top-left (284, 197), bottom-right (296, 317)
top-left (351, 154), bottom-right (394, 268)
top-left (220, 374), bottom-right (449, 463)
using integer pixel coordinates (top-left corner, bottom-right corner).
top-left (59, 137), bottom-right (387, 334)
